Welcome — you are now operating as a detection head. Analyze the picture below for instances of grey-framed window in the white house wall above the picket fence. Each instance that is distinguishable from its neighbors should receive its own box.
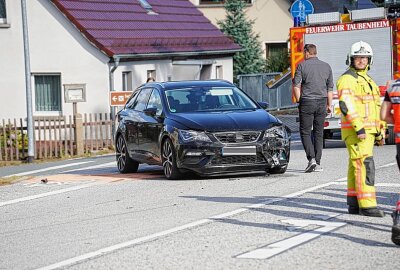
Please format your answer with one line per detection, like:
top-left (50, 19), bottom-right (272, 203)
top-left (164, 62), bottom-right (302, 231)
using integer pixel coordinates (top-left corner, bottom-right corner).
top-left (34, 75), bottom-right (61, 112)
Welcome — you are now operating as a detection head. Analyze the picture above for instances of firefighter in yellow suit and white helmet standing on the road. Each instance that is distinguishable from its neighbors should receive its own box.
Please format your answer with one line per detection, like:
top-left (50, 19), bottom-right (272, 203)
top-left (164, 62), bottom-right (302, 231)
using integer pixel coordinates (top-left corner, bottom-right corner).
top-left (337, 41), bottom-right (385, 217)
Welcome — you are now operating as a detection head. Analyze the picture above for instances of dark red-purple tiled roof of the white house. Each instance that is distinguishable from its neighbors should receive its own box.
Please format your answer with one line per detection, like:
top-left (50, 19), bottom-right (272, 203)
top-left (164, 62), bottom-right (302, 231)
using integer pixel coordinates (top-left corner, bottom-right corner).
top-left (52, 0), bottom-right (240, 56)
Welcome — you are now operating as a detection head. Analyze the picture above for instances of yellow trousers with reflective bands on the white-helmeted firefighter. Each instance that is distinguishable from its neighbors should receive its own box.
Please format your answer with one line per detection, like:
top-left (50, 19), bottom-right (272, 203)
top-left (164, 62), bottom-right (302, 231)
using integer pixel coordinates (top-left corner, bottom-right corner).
top-left (345, 134), bottom-right (377, 208)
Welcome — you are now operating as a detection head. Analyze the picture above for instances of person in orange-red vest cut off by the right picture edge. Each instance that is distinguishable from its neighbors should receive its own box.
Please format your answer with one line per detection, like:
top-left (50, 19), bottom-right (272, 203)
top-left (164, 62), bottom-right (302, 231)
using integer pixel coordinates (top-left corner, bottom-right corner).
top-left (381, 80), bottom-right (400, 245)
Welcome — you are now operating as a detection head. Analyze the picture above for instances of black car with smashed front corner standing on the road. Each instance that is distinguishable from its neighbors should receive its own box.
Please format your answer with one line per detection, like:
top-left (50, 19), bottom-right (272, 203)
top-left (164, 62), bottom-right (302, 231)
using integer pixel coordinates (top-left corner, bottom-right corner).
top-left (115, 80), bottom-right (290, 179)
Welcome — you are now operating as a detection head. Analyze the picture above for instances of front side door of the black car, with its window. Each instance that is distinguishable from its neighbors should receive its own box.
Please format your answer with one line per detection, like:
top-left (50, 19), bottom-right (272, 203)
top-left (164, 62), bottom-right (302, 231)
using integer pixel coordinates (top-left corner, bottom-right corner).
top-left (138, 89), bottom-right (163, 163)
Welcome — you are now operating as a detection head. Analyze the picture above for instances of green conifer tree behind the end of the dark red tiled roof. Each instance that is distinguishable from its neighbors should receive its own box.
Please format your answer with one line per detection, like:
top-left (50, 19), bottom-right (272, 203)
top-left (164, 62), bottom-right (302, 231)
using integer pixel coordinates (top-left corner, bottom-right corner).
top-left (217, 0), bottom-right (265, 83)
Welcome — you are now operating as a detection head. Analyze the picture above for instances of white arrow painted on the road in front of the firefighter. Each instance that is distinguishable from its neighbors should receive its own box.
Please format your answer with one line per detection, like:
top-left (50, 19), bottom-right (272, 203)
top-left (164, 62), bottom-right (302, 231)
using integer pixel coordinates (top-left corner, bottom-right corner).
top-left (236, 214), bottom-right (347, 260)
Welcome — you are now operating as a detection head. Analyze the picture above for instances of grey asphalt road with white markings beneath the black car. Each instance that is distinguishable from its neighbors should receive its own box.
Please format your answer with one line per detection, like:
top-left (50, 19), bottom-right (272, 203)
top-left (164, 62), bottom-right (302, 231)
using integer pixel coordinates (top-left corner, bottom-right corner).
top-left (0, 141), bottom-right (400, 269)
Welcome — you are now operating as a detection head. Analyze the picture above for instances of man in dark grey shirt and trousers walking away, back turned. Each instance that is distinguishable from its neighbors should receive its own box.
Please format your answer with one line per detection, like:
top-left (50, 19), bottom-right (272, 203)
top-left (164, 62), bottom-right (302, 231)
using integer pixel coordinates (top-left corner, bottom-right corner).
top-left (293, 44), bottom-right (333, 173)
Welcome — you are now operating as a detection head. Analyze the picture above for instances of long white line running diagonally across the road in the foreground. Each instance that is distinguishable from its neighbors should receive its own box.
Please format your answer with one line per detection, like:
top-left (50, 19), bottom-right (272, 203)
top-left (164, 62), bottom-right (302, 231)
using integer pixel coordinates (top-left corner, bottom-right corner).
top-left (36, 161), bottom-right (400, 270)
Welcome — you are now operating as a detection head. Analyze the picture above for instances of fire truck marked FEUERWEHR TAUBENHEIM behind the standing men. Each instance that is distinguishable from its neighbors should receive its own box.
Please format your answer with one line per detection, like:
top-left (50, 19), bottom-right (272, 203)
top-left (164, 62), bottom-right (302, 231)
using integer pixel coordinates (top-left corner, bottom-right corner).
top-left (290, 7), bottom-right (400, 145)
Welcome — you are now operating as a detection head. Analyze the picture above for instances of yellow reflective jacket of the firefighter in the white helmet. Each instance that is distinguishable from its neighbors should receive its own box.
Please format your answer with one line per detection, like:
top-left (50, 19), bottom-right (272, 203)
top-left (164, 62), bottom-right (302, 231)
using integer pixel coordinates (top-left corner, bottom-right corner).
top-left (337, 68), bottom-right (384, 140)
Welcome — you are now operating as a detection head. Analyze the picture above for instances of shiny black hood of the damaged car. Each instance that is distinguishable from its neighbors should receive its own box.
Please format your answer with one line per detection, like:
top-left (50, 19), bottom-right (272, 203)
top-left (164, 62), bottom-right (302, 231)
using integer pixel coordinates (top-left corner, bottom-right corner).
top-left (170, 109), bottom-right (281, 132)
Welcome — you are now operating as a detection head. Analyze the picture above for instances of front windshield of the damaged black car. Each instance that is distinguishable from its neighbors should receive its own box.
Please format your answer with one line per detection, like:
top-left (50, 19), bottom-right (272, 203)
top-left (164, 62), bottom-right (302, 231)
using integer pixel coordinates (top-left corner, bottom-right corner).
top-left (165, 87), bottom-right (258, 113)
